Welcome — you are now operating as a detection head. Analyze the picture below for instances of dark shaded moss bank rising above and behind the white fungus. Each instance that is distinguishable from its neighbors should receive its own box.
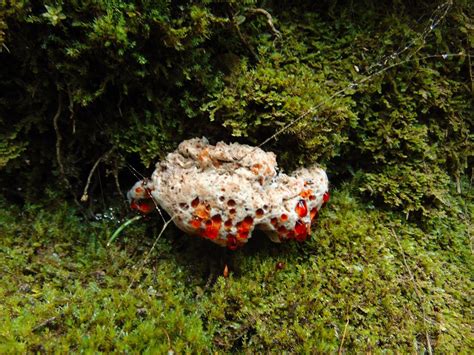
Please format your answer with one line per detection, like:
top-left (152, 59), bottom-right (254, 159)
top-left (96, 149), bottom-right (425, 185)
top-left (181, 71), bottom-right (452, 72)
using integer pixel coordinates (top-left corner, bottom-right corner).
top-left (0, 1), bottom-right (473, 215)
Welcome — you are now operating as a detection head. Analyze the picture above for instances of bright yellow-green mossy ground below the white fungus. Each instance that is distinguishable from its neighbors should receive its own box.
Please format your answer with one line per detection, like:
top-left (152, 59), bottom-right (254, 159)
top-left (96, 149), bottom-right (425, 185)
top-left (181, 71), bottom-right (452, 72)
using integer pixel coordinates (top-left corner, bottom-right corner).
top-left (0, 186), bottom-right (474, 353)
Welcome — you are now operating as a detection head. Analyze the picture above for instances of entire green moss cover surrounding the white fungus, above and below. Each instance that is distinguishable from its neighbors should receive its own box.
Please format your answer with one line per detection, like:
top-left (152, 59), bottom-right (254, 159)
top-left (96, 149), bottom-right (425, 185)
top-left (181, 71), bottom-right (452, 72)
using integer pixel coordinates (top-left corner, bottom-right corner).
top-left (0, 0), bottom-right (474, 353)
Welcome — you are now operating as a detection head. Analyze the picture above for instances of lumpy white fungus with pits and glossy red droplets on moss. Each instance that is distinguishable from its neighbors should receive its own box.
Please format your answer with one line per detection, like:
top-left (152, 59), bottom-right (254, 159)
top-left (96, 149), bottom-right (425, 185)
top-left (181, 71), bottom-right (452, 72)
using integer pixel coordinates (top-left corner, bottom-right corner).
top-left (128, 138), bottom-right (329, 250)
